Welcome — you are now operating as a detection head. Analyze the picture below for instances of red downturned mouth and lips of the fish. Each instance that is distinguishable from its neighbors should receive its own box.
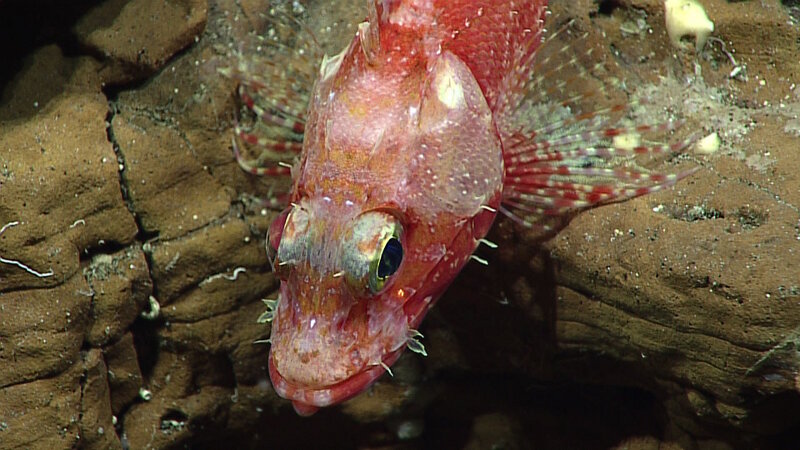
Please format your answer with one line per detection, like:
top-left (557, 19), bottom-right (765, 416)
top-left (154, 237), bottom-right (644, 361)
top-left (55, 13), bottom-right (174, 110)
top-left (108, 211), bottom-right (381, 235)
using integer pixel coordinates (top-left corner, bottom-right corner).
top-left (269, 346), bottom-right (404, 416)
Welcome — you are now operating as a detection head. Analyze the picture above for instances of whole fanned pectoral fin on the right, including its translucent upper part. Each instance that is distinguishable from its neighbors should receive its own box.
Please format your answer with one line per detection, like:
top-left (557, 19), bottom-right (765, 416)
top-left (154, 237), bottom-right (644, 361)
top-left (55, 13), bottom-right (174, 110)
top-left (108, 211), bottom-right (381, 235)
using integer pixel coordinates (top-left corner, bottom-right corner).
top-left (495, 16), bottom-right (697, 238)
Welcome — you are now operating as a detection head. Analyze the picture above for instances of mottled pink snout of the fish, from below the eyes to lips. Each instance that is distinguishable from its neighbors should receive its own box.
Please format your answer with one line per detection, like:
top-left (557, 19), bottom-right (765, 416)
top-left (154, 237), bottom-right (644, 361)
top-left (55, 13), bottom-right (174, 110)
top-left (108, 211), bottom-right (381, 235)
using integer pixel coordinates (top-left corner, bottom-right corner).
top-left (269, 276), bottom-right (407, 413)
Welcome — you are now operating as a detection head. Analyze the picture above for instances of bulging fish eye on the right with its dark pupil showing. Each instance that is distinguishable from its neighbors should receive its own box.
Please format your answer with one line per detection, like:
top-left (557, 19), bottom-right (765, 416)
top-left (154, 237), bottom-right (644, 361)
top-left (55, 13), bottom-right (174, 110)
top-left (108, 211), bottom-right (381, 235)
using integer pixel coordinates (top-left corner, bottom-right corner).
top-left (342, 211), bottom-right (403, 295)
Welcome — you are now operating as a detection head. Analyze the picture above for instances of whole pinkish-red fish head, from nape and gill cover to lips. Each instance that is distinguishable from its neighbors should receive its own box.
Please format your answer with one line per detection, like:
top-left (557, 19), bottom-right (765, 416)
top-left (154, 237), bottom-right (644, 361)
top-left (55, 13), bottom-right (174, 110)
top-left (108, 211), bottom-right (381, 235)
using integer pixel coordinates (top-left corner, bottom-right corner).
top-left (269, 19), bottom-right (503, 414)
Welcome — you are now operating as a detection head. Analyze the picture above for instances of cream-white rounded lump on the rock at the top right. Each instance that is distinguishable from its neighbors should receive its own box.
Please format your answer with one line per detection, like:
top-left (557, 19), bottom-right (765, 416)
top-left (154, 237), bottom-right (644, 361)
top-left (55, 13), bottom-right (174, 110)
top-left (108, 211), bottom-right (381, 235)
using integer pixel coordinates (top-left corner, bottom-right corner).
top-left (664, 0), bottom-right (714, 53)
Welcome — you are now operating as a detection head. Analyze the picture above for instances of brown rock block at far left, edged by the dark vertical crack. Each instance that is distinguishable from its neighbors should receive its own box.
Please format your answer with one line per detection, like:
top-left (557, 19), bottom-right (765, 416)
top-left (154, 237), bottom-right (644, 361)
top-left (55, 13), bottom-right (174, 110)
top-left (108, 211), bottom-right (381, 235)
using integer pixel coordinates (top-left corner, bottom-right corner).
top-left (0, 23), bottom-right (137, 448)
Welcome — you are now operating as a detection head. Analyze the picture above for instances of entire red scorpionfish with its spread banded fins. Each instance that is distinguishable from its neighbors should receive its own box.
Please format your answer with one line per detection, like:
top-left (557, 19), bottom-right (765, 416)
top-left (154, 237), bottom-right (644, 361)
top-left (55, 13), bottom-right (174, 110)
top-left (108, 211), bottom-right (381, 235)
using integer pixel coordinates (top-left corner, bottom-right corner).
top-left (221, 0), bottom-right (690, 415)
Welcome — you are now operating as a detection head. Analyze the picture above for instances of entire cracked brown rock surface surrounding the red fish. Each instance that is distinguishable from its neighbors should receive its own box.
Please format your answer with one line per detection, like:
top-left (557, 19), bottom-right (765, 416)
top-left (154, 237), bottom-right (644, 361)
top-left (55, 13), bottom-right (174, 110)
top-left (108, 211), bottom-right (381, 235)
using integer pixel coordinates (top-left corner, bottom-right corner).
top-left (0, 0), bottom-right (800, 448)
